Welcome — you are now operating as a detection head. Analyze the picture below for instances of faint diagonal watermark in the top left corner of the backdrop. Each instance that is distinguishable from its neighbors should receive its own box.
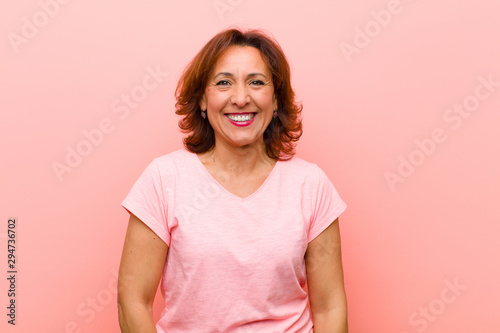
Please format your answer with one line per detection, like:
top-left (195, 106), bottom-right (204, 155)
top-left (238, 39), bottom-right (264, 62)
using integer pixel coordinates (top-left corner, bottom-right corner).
top-left (7, 0), bottom-right (71, 53)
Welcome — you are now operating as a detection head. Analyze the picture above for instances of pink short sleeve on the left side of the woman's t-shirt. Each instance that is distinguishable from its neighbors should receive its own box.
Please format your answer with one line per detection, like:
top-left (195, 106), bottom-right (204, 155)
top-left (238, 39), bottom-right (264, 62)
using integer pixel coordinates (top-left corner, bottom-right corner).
top-left (121, 159), bottom-right (170, 246)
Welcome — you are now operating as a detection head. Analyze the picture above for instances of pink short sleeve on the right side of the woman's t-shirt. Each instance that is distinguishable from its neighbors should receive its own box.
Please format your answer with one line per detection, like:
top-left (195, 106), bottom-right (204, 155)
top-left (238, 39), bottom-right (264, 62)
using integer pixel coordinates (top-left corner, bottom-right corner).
top-left (307, 166), bottom-right (347, 242)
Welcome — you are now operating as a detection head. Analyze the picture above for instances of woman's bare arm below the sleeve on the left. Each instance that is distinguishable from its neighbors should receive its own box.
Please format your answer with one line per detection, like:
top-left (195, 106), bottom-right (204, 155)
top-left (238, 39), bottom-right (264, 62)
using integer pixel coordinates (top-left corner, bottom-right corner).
top-left (118, 214), bottom-right (168, 333)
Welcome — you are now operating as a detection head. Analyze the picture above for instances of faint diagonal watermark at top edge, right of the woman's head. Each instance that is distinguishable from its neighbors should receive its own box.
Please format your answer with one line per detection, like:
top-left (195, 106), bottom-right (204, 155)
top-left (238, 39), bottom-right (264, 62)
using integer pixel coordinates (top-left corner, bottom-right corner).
top-left (339, 0), bottom-right (404, 63)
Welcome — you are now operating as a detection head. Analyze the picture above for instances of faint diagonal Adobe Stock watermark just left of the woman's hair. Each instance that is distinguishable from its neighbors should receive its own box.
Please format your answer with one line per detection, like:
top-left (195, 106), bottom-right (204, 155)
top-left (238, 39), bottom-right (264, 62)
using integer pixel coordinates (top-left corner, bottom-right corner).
top-left (51, 65), bottom-right (170, 182)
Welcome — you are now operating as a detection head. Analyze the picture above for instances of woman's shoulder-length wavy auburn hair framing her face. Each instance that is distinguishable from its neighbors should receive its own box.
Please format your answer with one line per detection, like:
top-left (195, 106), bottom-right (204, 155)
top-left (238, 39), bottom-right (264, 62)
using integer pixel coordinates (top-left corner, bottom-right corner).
top-left (175, 28), bottom-right (302, 160)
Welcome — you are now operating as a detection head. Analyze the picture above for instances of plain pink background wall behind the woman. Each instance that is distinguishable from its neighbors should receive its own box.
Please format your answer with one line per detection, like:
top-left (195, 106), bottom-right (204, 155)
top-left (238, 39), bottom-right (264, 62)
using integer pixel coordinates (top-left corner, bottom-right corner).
top-left (0, 0), bottom-right (500, 333)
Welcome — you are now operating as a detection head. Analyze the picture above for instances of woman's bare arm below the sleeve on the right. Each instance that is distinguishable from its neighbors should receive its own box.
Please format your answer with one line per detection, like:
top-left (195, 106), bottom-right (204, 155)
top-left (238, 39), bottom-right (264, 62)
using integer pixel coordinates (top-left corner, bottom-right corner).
top-left (305, 219), bottom-right (347, 333)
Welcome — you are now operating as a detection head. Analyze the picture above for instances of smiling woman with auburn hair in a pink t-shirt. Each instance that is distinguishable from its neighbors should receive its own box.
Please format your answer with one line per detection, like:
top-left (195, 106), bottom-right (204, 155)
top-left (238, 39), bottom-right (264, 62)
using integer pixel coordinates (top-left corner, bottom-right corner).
top-left (118, 29), bottom-right (347, 333)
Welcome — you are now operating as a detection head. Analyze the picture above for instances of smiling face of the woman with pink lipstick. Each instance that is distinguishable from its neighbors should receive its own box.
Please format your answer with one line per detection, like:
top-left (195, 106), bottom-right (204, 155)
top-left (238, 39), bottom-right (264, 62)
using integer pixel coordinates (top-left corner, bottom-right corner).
top-left (200, 46), bottom-right (277, 147)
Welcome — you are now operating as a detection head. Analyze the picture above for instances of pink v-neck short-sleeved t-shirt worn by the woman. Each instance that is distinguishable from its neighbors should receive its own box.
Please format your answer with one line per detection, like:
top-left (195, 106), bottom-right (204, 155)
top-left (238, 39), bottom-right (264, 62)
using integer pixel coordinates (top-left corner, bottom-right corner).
top-left (122, 149), bottom-right (346, 333)
